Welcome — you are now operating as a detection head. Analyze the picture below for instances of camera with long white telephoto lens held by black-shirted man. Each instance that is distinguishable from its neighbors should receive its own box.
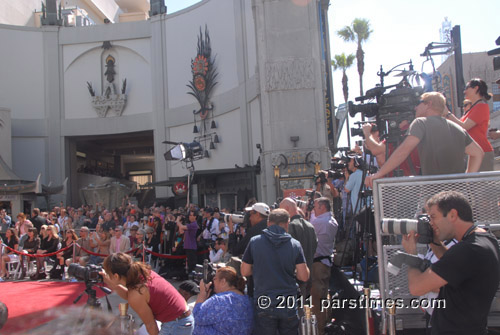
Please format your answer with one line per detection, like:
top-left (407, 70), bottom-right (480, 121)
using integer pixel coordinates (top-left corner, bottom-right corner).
top-left (382, 214), bottom-right (433, 244)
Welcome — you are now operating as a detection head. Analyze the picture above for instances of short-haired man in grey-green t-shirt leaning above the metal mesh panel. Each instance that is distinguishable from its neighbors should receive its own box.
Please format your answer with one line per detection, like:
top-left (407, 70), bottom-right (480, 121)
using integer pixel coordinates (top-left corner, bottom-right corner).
top-left (365, 92), bottom-right (484, 187)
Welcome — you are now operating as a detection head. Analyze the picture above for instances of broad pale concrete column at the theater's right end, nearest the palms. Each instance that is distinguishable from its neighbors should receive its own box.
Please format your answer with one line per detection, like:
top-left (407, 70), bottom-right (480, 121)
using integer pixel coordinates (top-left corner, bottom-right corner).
top-left (252, 0), bottom-right (330, 203)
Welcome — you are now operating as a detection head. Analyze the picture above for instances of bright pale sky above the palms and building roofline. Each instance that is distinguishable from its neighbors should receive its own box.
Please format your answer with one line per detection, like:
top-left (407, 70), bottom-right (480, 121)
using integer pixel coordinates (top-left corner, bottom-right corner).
top-left (165, 0), bottom-right (500, 147)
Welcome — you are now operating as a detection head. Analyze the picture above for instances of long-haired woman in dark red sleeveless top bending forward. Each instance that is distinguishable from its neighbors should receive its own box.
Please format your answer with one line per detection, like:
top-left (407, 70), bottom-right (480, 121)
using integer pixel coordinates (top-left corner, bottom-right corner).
top-left (101, 252), bottom-right (194, 335)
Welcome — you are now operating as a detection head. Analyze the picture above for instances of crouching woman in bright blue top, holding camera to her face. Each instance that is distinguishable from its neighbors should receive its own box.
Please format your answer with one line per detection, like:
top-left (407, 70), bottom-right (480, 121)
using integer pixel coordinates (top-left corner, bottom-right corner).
top-left (193, 266), bottom-right (253, 335)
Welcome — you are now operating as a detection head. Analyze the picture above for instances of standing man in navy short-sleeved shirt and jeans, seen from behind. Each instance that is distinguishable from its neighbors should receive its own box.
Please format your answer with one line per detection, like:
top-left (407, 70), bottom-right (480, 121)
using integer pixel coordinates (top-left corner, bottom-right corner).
top-left (241, 209), bottom-right (309, 335)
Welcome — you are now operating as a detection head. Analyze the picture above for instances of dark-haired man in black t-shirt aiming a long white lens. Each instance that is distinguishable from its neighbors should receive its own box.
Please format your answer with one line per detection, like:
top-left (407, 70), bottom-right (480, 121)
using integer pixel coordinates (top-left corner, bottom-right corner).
top-left (402, 191), bottom-right (500, 335)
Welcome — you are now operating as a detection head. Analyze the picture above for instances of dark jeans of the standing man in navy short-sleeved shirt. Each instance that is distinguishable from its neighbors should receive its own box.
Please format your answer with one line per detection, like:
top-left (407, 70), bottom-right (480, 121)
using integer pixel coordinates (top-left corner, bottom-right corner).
top-left (253, 308), bottom-right (299, 335)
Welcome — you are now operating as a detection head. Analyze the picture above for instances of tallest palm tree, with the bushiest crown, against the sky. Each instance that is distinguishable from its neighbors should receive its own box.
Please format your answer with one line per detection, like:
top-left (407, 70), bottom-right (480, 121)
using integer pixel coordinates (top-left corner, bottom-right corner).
top-left (337, 19), bottom-right (373, 96)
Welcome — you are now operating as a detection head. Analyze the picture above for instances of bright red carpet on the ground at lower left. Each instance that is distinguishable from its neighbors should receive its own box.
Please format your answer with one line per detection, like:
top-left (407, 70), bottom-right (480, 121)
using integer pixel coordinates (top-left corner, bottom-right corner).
top-left (0, 281), bottom-right (104, 334)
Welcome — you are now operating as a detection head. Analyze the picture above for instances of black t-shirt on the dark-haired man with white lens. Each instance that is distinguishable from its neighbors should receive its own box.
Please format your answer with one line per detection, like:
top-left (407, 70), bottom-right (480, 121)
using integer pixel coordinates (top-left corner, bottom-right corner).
top-left (431, 233), bottom-right (500, 335)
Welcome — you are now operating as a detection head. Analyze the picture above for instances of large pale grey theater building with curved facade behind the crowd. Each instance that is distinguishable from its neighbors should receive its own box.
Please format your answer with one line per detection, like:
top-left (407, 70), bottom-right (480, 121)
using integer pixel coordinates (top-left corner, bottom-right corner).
top-left (0, 0), bottom-right (334, 208)
